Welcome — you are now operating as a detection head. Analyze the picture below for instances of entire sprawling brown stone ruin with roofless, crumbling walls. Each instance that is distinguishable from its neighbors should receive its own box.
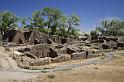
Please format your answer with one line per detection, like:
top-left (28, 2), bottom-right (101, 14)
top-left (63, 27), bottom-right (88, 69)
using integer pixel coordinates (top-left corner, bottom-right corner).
top-left (2, 29), bottom-right (124, 68)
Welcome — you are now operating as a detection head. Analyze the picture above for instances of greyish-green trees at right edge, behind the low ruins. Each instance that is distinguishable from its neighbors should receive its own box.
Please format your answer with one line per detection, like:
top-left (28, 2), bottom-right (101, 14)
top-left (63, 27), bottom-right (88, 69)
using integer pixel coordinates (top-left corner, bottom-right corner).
top-left (91, 17), bottom-right (124, 36)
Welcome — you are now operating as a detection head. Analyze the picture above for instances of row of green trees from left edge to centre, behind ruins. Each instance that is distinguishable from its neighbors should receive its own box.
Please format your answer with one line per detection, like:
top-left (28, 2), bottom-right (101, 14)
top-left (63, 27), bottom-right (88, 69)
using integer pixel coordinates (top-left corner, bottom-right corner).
top-left (0, 8), bottom-right (80, 38)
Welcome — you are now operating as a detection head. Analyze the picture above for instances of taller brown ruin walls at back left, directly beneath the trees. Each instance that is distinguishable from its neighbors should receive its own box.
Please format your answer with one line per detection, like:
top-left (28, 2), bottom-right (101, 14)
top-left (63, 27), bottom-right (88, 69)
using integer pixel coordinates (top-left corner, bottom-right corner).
top-left (4, 29), bottom-right (73, 45)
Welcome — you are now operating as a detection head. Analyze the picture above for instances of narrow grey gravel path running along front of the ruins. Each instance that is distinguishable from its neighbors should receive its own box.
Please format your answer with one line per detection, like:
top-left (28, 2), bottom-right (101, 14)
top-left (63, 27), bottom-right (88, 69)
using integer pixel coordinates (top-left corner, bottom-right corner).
top-left (44, 52), bottom-right (114, 72)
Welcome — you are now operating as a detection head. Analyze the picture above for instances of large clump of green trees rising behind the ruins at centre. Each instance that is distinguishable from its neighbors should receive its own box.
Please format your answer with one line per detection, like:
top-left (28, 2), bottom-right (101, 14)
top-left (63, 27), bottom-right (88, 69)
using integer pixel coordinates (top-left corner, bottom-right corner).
top-left (30, 8), bottom-right (80, 37)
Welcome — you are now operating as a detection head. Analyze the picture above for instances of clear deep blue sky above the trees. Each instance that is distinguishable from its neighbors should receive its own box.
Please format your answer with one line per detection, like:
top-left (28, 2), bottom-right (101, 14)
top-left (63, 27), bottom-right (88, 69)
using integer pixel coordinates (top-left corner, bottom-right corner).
top-left (0, 0), bottom-right (124, 31)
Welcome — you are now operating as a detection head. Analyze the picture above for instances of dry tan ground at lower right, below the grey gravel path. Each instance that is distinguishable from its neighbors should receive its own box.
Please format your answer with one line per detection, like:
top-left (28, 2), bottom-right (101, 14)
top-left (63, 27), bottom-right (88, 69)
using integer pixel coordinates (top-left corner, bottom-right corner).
top-left (33, 51), bottom-right (124, 82)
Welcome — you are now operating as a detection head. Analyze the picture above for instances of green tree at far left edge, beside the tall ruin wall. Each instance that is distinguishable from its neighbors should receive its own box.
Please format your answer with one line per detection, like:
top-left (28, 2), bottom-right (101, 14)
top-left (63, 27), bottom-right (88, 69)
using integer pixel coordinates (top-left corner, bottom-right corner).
top-left (0, 10), bottom-right (18, 38)
